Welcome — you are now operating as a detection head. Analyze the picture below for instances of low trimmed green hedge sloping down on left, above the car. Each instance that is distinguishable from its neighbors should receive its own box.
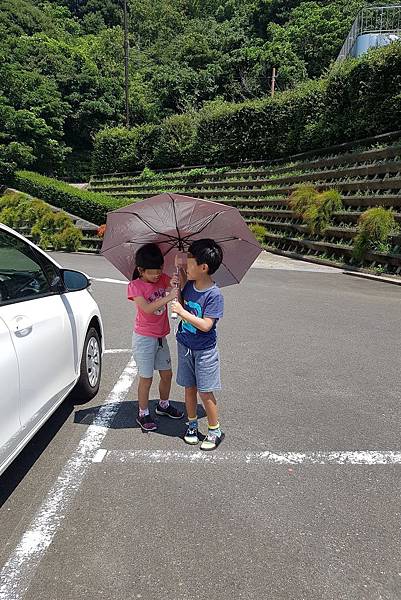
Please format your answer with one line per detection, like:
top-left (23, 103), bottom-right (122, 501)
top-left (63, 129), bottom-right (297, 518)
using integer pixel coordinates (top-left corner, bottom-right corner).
top-left (12, 171), bottom-right (126, 225)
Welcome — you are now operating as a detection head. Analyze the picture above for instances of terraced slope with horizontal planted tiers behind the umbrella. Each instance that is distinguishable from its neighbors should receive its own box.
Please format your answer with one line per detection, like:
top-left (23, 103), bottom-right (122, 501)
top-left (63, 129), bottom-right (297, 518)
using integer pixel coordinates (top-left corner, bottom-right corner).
top-left (90, 134), bottom-right (401, 273)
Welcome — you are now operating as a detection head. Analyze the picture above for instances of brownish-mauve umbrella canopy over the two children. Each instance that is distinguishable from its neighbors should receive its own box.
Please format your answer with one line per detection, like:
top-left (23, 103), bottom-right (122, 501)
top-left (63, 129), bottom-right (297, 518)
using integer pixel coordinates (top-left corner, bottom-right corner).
top-left (101, 194), bottom-right (262, 287)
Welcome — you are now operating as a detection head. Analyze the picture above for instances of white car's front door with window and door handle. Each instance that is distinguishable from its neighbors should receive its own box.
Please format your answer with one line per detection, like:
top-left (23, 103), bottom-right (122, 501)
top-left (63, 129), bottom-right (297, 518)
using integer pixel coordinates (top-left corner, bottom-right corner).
top-left (0, 229), bottom-right (76, 431)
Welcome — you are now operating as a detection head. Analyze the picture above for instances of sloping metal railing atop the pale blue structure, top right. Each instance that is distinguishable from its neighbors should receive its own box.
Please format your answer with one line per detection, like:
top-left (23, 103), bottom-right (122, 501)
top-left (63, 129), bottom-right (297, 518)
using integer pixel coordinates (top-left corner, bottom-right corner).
top-left (337, 4), bottom-right (401, 62)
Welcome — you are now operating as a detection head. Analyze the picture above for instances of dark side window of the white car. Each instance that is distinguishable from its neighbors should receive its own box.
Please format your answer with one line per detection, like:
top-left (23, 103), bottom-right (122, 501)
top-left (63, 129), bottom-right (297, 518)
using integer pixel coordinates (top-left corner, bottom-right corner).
top-left (0, 230), bottom-right (56, 305)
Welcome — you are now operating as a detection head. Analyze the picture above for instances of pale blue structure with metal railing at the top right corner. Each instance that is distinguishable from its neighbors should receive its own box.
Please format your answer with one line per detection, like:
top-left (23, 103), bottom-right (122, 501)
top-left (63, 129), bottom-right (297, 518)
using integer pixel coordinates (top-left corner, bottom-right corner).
top-left (337, 4), bottom-right (401, 62)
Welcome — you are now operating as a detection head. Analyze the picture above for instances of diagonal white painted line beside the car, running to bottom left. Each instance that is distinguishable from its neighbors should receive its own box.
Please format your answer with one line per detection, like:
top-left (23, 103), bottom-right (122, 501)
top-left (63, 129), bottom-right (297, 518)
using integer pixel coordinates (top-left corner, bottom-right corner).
top-left (0, 360), bottom-right (137, 600)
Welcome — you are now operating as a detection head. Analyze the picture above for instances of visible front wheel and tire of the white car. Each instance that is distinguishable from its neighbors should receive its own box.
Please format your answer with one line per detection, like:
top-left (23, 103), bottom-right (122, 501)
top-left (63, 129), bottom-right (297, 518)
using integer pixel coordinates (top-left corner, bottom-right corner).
top-left (73, 327), bottom-right (102, 402)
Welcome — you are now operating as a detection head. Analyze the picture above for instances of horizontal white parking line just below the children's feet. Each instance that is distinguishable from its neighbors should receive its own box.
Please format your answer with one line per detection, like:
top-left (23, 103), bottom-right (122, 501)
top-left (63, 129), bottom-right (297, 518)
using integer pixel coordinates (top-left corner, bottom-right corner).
top-left (93, 448), bottom-right (401, 465)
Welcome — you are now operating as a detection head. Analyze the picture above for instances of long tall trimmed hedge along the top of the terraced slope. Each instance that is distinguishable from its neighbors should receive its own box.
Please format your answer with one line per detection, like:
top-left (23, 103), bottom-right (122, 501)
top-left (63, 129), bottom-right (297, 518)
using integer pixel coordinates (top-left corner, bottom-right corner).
top-left (93, 42), bottom-right (401, 173)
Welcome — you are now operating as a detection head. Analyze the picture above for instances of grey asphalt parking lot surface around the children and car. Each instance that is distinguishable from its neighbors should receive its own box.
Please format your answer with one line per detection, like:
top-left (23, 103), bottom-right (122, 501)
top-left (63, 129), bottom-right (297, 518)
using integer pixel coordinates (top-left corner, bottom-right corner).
top-left (0, 254), bottom-right (401, 600)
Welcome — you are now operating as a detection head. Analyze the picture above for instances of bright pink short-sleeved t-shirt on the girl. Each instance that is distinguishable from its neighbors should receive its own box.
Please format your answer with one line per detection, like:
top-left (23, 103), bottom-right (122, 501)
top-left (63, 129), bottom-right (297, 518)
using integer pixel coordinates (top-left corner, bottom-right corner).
top-left (128, 273), bottom-right (170, 337)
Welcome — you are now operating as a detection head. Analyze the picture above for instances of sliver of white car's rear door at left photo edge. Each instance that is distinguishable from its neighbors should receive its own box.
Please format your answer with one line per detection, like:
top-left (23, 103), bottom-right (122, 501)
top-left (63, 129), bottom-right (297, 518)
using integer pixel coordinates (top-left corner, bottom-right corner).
top-left (0, 314), bottom-right (21, 473)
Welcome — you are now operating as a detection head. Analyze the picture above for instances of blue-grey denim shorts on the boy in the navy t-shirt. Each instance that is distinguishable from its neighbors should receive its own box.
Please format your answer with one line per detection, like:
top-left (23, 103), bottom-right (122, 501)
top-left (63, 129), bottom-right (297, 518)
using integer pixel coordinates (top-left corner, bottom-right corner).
top-left (177, 342), bottom-right (221, 392)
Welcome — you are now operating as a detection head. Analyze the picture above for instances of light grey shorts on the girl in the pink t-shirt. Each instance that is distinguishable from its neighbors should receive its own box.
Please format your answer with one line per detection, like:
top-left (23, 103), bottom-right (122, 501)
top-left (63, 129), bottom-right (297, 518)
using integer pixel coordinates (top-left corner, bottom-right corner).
top-left (132, 332), bottom-right (171, 379)
